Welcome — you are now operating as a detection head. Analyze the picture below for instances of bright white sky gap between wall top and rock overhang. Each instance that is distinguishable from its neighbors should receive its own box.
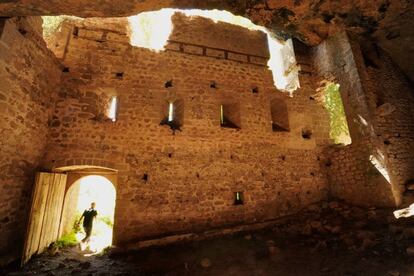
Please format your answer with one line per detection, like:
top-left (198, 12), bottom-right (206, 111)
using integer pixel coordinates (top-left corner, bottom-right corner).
top-left (128, 9), bottom-right (300, 93)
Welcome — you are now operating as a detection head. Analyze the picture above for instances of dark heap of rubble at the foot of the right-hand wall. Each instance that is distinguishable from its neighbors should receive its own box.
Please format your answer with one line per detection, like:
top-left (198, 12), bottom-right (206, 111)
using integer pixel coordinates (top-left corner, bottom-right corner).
top-left (273, 201), bottom-right (414, 255)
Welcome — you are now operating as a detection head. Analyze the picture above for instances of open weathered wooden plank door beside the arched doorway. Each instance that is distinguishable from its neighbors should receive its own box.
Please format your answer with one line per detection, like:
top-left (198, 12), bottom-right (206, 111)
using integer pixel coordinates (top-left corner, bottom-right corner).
top-left (21, 172), bottom-right (66, 265)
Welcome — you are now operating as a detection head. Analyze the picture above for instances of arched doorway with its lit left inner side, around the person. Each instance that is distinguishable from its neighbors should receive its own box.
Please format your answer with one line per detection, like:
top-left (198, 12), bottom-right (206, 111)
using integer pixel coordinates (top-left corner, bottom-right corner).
top-left (61, 173), bottom-right (116, 252)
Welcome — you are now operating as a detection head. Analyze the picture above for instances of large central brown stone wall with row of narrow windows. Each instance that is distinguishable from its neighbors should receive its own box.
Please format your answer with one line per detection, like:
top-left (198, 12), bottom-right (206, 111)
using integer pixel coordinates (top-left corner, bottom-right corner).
top-left (45, 15), bottom-right (330, 244)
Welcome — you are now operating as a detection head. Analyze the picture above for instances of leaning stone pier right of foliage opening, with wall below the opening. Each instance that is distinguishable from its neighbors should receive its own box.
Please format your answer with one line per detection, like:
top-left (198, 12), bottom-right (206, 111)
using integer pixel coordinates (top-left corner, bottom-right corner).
top-left (315, 32), bottom-right (395, 206)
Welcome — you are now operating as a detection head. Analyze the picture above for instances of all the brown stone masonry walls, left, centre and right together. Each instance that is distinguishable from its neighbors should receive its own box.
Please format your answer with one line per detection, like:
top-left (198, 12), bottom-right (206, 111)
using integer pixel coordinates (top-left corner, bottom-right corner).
top-left (0, 10), bottom-right (414, 263)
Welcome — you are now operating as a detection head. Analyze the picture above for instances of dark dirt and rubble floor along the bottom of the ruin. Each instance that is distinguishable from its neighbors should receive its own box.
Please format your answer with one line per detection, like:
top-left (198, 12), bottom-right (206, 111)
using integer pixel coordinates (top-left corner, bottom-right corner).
top-left (0, 202), bottom-right (414, 276)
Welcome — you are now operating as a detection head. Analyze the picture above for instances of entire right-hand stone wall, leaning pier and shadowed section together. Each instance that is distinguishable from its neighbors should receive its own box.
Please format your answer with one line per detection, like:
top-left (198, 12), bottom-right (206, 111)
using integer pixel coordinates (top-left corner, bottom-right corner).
top-left (315, 32), bottom-right (414, 206)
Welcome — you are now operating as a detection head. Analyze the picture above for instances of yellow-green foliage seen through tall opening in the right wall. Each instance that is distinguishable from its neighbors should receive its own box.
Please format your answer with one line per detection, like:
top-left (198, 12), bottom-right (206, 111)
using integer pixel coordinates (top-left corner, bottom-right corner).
top-left (324, 83), bottom-right (349, 144)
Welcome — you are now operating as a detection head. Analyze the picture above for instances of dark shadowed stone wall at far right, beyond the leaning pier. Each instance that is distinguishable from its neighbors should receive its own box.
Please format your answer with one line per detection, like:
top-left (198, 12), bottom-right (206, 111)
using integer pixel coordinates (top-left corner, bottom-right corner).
top-left (363, 45), bottom-right (414, 205)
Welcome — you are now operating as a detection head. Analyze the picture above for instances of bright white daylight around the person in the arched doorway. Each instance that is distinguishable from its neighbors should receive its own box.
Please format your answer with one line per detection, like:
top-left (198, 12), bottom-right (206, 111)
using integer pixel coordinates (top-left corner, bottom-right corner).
top-left (76, 175), bottom-right (116, 256)
